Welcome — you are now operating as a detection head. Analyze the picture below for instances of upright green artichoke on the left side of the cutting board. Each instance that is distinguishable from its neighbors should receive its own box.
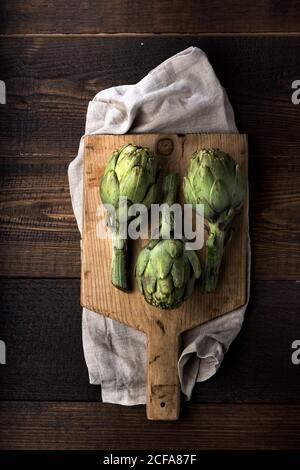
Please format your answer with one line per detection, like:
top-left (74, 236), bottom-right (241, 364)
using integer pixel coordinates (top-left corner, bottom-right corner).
top-left (100, 144), bottom-right (157, 291)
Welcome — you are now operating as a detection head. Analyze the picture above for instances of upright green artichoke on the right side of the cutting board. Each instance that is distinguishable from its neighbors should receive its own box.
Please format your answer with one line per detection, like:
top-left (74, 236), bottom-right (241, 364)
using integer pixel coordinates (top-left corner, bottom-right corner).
top-left (183, 149), bottom-right (246, 292)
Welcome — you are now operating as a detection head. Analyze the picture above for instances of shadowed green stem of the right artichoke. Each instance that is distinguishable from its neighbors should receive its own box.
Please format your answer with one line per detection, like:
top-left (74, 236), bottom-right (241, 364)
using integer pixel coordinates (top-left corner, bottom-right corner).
top-left (201, 224), bottom-right (226, 293)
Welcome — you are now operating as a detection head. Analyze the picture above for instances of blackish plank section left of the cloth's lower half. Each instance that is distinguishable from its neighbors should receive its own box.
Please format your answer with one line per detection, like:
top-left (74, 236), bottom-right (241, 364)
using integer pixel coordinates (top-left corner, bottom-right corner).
top-left (0, 279), bottom-right (101, 400)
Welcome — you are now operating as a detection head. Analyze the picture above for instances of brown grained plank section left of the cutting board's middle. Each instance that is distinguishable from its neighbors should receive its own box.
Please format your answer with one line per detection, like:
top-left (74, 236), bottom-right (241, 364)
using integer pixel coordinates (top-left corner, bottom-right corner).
top-left (0, 156), bottom-right (80, 277)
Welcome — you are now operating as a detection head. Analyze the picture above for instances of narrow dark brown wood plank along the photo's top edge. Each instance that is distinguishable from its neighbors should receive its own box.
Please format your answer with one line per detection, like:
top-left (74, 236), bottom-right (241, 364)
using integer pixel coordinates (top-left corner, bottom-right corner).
top-left (1, 0), bottom-right (300, 34)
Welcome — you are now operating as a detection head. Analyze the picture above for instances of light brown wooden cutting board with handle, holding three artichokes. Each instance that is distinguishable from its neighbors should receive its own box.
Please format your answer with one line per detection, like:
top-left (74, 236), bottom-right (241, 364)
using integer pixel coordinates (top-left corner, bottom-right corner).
top-left (81, 134), bottom-right (248, 420)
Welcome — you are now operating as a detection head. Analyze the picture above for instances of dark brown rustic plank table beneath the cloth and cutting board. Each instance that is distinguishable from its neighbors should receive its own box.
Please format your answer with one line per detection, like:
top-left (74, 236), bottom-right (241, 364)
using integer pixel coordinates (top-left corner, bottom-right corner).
top-left (0, 0), bottom-right (300, 450)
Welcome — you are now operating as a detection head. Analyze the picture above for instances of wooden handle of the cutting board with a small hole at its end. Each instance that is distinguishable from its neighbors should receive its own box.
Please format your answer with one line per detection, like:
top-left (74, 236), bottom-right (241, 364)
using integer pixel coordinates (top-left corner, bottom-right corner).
top-left (147, 319), bottom-right (180, 420)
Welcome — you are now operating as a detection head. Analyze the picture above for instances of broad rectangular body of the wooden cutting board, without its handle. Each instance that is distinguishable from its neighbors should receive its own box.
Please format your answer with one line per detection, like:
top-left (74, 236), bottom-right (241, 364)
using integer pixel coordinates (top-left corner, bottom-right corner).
top-left (81, 134), bottom-right (248, 333)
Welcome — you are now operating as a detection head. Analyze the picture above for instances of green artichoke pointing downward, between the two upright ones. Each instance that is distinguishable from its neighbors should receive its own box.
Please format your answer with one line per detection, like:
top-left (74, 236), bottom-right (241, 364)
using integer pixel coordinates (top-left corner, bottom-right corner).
top-left (135, 174), bottom-right (201, 309)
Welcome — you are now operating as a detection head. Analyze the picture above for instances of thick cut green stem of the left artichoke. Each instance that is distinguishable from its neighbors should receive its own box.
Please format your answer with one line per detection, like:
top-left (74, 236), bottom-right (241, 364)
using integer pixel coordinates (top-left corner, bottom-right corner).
top-left (111, 240), bottom-right (130, 291)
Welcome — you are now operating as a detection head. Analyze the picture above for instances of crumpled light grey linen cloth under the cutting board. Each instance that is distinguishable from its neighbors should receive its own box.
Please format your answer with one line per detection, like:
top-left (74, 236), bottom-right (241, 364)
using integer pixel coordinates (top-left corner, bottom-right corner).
top-left (68, 47), bottom-right (250, 405)
